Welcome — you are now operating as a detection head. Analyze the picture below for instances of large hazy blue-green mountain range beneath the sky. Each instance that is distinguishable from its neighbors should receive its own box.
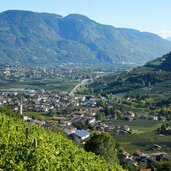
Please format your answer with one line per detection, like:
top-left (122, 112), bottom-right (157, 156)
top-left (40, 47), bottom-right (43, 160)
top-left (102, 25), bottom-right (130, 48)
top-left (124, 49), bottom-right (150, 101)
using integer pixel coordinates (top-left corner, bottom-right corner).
top-left (0, 10), bottom-right (171, 65)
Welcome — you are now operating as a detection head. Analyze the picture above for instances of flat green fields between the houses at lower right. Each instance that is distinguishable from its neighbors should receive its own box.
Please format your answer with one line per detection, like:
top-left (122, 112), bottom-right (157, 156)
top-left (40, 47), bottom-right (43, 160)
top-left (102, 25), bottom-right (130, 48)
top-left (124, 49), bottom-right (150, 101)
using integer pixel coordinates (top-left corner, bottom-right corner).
top-left (109, 119), bottom-right (171, 156)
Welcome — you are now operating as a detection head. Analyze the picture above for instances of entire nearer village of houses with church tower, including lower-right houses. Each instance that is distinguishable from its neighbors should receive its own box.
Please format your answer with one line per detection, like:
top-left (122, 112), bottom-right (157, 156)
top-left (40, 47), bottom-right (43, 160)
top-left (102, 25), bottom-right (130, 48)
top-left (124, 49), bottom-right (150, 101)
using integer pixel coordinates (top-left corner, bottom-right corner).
top-left (0, 88), bottom-right (171, 168)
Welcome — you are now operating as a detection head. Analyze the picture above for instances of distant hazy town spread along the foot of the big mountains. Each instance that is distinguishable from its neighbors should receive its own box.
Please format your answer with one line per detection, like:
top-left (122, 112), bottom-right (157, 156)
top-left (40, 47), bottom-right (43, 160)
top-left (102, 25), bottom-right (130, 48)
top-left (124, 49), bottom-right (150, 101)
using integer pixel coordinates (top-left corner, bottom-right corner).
top-left (0, 64), bottom-right (98, 80)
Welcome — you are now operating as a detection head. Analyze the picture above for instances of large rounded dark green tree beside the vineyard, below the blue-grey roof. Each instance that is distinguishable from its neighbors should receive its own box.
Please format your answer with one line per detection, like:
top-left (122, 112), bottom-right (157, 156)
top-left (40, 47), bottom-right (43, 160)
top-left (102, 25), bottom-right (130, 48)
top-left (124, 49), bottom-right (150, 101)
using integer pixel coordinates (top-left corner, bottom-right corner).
top-left (85, 132), bottom-right (118, 163)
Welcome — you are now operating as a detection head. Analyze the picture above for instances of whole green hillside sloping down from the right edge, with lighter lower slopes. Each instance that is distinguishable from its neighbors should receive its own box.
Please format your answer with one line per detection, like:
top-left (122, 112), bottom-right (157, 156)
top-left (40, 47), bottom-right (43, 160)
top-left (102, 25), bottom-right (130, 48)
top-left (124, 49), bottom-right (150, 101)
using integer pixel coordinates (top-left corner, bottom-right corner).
top-left (90, 53), bottom-right (171, 120)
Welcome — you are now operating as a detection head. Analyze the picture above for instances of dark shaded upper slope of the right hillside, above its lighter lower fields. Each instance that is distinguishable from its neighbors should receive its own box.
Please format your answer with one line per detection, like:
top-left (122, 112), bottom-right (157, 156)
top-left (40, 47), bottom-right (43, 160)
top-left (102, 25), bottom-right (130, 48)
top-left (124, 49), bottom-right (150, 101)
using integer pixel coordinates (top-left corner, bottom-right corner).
top-left (92, 53), bottom-right (171, 94)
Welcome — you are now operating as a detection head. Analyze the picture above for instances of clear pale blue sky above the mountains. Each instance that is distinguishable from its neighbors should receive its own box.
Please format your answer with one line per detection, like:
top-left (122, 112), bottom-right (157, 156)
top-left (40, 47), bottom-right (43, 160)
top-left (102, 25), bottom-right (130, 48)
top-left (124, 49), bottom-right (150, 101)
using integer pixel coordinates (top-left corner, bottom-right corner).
top-left (0, 0), bottom-right (171, 38)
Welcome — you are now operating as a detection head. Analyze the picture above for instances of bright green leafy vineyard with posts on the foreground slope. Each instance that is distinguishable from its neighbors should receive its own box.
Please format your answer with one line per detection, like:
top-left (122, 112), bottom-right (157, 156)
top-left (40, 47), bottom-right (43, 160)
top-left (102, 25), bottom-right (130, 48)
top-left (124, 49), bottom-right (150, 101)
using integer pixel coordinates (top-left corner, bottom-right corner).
top-left (0, 113), bottom-right (123, 171)
